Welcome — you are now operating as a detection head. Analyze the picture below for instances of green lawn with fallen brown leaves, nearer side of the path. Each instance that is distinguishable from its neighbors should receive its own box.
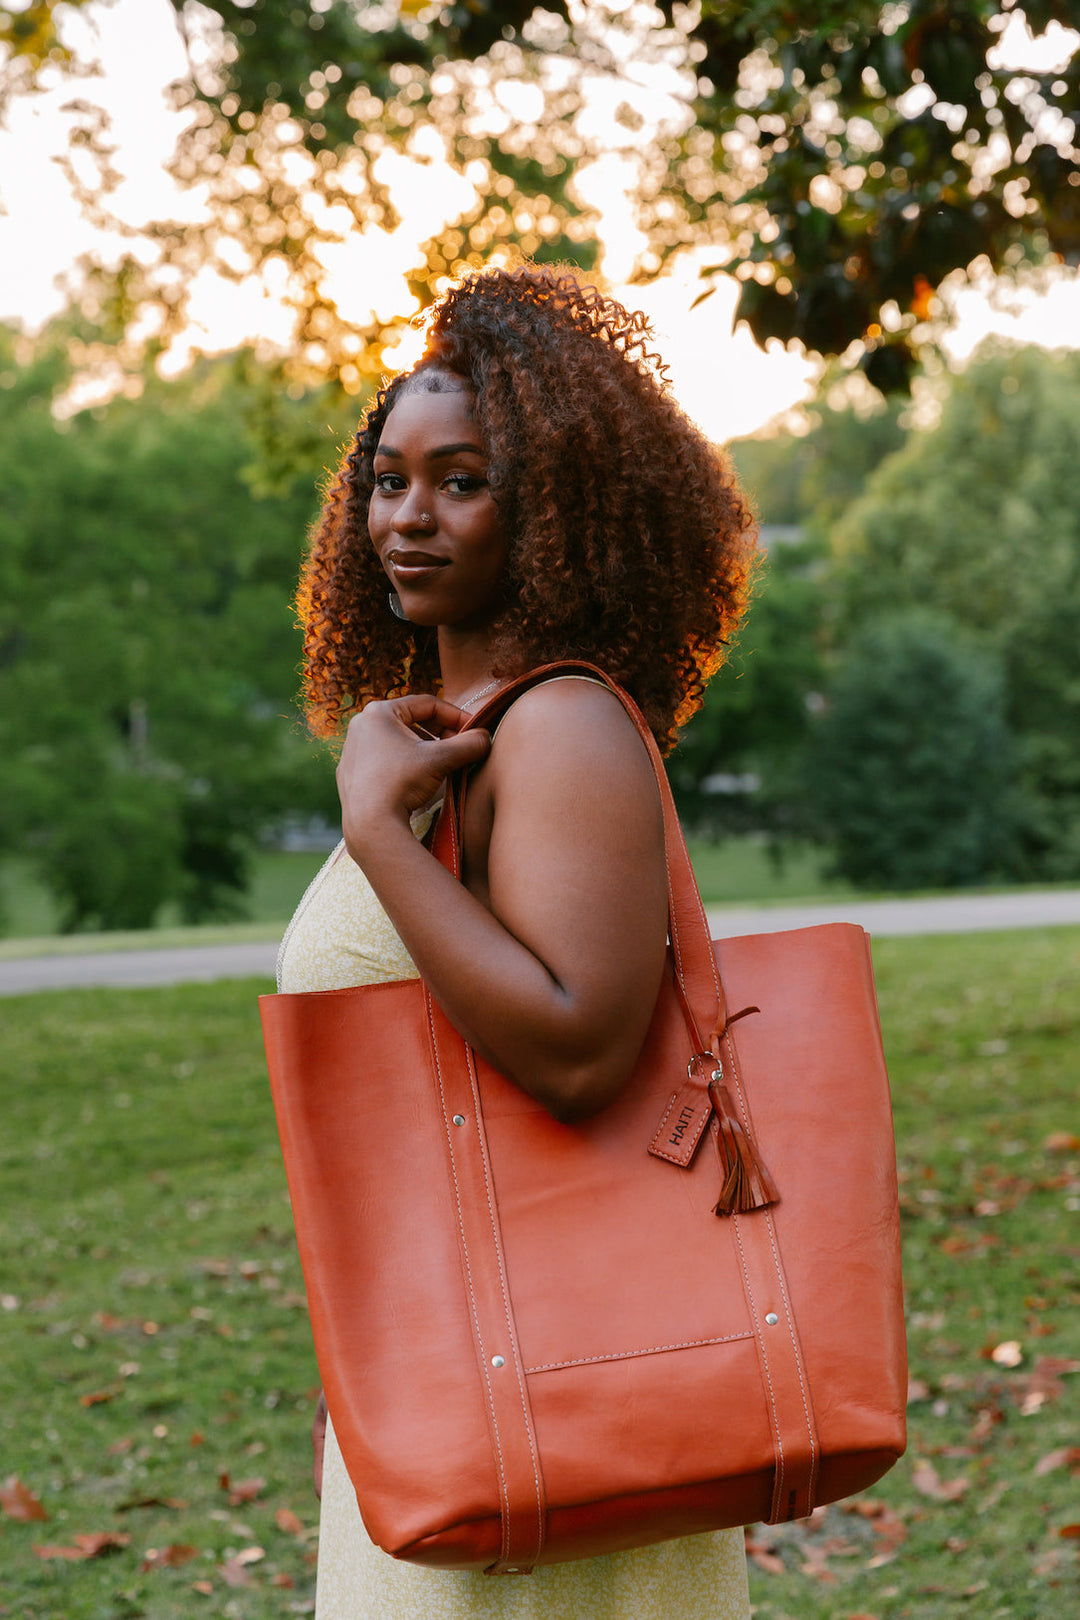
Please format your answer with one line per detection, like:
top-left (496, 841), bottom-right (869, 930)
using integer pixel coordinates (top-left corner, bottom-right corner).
top-left (0, 928), bottom-right (1080, 1620)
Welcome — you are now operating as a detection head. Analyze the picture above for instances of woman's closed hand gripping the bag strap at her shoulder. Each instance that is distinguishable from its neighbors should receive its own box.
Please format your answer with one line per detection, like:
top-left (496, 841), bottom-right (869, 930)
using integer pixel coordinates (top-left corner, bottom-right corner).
top-left (337, 695), bottom-right (491, 863)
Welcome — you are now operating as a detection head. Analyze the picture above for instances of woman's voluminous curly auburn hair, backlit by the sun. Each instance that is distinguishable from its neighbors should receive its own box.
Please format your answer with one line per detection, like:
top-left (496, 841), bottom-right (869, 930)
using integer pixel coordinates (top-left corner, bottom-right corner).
top-left (298, 266), bottom-right (756, 750)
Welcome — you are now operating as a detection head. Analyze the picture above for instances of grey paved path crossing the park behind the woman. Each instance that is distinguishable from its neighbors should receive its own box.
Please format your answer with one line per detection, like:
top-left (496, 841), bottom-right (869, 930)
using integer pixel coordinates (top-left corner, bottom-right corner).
top-left (0, 889), bottom-right (1080, 995)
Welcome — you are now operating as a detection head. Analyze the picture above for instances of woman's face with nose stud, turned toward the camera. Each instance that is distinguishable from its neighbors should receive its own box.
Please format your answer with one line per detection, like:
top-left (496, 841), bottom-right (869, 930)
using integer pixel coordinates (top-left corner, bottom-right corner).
top-left (368, 387), bottom-right (507, 630)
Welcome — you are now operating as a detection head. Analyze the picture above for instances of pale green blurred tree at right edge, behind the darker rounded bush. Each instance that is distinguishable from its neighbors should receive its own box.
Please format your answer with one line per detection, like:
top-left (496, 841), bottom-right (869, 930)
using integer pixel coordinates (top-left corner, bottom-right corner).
top-left (836, 345), bottom-right (1080, 878)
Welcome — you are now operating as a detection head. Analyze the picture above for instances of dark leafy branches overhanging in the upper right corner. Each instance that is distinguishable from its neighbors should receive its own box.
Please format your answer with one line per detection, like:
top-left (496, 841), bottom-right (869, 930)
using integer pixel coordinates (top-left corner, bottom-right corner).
top-left (690, 0), bottom-right (1080, 390)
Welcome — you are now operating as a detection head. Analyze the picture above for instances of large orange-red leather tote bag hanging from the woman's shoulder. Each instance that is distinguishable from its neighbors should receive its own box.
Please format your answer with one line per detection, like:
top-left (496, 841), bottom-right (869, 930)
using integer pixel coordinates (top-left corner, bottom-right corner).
top-left (261, 664), bottom-right (907, 1573)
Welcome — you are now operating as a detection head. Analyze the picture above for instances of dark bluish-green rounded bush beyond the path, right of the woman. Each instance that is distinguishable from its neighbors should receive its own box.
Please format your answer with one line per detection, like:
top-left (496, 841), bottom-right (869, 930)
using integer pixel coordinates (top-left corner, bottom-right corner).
top-left (808, 612), bottom-right (1017, 889)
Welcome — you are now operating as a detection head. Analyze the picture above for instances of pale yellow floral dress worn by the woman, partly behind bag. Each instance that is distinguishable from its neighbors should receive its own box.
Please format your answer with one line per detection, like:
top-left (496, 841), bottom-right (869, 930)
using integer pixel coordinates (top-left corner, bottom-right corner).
top-left (279, 815), bottom-right (750, 1620)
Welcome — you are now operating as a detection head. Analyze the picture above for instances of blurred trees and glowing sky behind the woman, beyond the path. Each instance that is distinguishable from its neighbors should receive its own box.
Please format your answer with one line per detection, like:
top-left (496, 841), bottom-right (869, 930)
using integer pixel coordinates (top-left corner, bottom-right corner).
top-left (0, 0), bottom-right (1080, 936)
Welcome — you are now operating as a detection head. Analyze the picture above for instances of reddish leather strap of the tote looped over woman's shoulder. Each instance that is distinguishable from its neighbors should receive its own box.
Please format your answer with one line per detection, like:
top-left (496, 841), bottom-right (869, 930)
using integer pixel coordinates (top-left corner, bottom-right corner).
top-left (431, 659), bottom-right (724, 1051)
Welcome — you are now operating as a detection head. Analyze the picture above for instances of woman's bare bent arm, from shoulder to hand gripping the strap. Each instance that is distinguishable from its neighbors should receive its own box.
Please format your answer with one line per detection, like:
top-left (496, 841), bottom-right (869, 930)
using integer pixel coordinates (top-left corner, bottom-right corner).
top-left (338, 680), bottom-right (667, 1119)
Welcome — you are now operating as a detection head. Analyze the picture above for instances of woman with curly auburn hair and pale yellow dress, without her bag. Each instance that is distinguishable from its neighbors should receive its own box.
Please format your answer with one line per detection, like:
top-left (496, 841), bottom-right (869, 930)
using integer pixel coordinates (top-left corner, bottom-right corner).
top-left (280, 269), bottom-right (755, 1620)
